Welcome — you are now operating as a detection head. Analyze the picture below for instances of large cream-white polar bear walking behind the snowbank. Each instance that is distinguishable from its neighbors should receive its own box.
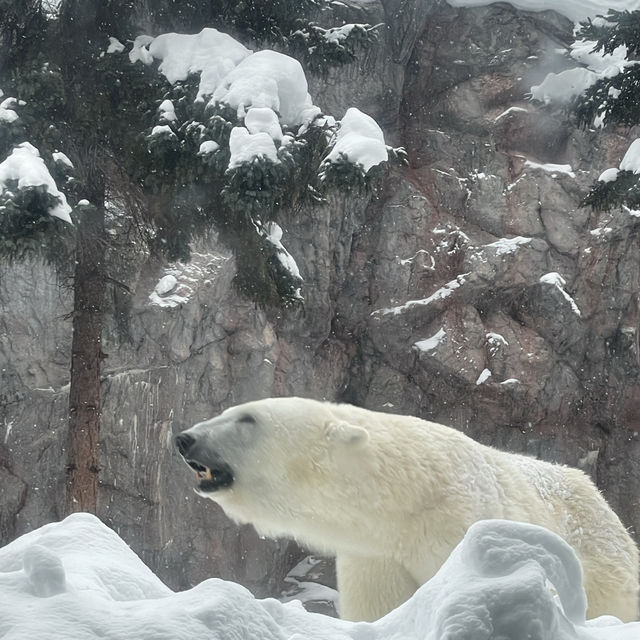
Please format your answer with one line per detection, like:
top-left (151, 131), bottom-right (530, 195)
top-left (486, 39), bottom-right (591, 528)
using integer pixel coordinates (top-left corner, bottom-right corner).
top-left (176, 397), bottom-right (638, 621)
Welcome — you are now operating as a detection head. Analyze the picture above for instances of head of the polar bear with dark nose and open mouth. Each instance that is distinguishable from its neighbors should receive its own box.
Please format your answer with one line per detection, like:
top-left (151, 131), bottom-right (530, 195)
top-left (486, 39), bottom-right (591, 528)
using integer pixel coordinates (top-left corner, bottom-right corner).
top-left (176, 398), bottom-right (374, 546)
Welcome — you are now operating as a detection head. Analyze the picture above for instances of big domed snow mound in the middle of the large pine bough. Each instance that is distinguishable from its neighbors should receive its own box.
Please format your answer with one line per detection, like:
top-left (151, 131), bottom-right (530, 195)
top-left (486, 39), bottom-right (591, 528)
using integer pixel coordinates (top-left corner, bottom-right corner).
top-left (210, 49), bottom-right (320, 126)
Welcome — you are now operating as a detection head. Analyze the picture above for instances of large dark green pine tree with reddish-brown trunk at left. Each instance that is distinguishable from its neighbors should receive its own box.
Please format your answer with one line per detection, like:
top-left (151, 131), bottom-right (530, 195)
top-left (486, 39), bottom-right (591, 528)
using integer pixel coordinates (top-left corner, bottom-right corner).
top-left (0, 0), bottom-right (392, 512)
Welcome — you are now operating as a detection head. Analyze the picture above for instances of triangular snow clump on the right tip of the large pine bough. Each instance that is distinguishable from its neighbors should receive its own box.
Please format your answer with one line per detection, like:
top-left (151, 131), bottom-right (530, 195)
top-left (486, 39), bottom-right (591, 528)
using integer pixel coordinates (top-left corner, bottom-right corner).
top-left (325, 107), bottom-right (389, 173)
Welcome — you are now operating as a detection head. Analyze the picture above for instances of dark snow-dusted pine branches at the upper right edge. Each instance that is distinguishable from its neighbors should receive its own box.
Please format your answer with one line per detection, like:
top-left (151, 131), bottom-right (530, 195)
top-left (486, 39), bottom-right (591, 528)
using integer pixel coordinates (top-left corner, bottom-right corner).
top-left (574, 10), bottom-right (640, 211)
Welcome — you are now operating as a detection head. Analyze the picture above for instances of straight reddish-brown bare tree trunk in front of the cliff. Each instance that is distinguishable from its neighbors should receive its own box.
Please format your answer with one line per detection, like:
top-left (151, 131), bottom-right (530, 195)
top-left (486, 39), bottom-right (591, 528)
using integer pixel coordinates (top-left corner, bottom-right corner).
top-left (65, 202), bottom-right (106, 514)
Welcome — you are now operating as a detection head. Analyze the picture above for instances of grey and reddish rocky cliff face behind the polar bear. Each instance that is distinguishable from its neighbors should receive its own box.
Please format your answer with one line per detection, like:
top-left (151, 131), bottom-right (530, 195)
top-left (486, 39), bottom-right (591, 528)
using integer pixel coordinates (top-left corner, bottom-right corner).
top-left (0, 0), bottom-right (640, 595)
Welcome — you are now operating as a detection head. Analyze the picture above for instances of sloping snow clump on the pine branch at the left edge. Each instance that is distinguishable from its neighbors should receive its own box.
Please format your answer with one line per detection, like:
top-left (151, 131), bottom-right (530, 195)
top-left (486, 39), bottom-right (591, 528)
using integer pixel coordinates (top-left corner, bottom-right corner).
top-left (0, 142), bottom-right (71, 223)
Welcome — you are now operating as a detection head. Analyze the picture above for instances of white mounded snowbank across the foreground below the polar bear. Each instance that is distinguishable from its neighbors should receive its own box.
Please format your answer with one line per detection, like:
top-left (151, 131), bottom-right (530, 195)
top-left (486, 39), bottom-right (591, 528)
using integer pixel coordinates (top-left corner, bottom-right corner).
top-left (0, 514), bottom-right (640, 640)
